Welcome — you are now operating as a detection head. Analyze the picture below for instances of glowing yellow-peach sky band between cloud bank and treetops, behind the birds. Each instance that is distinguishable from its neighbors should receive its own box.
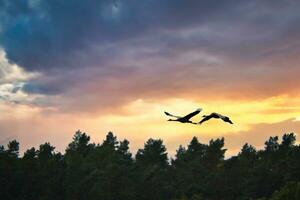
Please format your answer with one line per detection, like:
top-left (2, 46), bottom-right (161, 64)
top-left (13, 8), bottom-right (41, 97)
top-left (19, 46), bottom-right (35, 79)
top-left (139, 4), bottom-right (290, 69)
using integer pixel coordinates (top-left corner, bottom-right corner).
top-left (0, 96), bottom-right (300, 157)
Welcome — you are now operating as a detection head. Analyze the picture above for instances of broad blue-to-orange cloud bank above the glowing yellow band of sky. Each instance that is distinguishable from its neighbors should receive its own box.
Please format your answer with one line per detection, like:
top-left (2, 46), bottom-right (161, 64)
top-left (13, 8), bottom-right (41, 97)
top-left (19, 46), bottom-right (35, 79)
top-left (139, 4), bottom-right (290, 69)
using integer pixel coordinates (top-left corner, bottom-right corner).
top-left (0, 0), bottom-right (300, 112)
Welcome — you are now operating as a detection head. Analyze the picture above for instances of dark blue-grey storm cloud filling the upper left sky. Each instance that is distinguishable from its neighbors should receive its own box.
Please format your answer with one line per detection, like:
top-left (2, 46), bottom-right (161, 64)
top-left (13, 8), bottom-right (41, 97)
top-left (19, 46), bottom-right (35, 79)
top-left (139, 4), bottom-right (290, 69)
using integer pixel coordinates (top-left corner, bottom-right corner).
top-left (1, 0), bottom-right (230, 71)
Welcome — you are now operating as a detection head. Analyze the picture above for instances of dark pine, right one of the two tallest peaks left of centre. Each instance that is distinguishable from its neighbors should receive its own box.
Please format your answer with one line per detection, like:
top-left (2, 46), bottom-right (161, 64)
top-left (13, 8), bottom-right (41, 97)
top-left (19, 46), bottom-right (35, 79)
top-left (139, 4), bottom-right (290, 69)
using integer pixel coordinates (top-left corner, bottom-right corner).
top-left (82, 132), bottom-right (135, 200)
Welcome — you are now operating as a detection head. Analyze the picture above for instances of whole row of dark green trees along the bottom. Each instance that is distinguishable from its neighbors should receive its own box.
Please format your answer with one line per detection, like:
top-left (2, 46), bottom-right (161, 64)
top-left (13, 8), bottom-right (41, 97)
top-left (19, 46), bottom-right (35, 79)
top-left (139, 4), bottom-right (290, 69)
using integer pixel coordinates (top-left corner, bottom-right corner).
top-left (0, 131), bottom-right (300, 200)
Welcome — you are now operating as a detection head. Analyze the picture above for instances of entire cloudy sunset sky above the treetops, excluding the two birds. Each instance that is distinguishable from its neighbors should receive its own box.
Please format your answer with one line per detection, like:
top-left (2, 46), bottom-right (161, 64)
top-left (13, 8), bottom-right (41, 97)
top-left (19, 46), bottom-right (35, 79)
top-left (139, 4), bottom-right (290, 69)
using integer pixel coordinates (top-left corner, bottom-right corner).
top-left (0, 0), bottom-right (300, 156)
